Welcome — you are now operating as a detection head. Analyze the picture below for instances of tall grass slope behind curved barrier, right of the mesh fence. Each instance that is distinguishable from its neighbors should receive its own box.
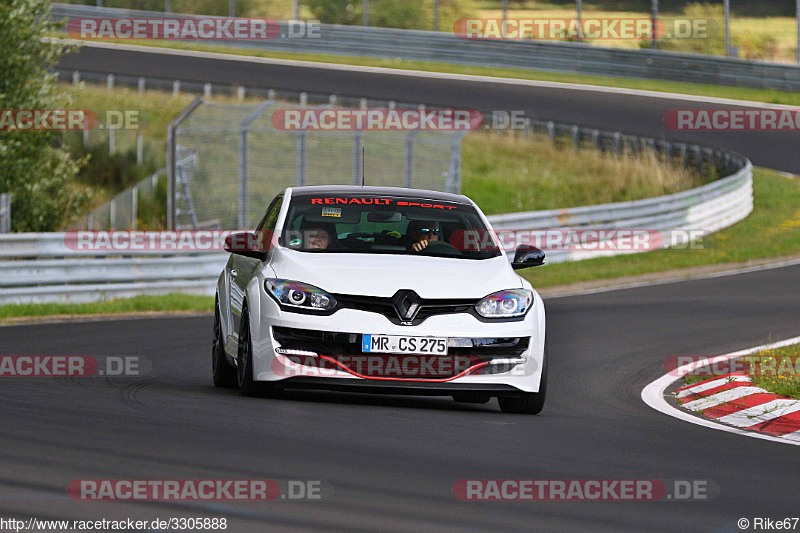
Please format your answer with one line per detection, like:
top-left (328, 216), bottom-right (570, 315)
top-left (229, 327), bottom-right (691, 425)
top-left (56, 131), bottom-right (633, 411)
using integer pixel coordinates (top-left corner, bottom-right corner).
top-left (461, 132), bottom-right (707, 215)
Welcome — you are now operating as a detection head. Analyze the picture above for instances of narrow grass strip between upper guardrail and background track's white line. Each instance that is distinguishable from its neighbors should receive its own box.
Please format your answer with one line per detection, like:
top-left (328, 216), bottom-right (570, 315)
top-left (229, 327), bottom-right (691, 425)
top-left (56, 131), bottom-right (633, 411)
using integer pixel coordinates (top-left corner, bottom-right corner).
top-left (58, 34), bottom-right (800, 105)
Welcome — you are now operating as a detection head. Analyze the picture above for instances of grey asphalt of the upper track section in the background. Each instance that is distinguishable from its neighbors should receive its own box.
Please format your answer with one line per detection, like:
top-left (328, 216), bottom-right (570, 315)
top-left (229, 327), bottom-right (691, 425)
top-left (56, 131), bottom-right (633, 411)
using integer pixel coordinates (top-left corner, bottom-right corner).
top-left (59, 47), bottom-right (800, 174)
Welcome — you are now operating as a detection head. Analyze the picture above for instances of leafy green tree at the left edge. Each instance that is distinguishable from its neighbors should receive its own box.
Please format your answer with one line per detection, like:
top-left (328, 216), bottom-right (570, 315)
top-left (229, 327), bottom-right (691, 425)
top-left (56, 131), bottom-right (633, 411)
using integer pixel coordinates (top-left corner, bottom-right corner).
top-left (0, 0), bottom-right (89, 231)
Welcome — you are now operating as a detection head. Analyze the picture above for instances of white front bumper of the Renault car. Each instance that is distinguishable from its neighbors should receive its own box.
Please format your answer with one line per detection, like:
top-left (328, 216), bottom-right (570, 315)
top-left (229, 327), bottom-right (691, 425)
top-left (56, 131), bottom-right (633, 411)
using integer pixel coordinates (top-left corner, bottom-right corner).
top-left (248, 287), bottom-right (545, 395)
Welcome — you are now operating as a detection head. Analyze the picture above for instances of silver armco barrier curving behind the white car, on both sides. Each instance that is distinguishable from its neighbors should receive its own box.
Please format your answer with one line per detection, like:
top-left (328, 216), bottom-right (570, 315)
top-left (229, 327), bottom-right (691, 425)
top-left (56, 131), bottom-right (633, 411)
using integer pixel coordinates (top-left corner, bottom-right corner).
top-left (0, 161), bottom-right (753, 304)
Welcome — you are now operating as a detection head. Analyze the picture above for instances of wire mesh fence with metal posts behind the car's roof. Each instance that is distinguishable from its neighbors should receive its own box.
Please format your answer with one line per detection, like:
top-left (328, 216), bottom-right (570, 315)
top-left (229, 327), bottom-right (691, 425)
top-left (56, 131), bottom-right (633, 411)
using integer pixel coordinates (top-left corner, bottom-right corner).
top-left (168, 96), bottom-right (463, 228)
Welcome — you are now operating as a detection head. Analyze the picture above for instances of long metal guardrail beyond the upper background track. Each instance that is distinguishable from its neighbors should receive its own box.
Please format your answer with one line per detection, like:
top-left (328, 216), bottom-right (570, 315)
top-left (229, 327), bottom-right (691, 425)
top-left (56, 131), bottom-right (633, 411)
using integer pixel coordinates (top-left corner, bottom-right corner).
top-left (52, 4), bottom-right (800, 91)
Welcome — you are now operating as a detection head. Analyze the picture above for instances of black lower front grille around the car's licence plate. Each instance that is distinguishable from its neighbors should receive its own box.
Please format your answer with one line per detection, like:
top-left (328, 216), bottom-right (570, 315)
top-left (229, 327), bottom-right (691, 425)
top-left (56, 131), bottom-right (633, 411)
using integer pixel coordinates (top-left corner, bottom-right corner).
top-left (272, 326), bottom-right (530, 379)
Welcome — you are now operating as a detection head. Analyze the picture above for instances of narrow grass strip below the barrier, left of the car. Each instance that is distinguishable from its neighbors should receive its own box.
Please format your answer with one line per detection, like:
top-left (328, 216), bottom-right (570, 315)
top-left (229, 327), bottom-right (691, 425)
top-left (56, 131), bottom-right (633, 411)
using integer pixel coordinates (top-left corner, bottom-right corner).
top-left (0, 294), bottom-right (214, 323)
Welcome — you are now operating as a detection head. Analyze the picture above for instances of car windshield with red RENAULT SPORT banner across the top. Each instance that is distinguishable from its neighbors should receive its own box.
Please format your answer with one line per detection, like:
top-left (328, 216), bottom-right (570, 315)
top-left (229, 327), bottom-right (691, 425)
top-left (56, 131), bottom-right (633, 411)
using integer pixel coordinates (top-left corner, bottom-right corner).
top-left (281, 194), bottom-right (500, 259)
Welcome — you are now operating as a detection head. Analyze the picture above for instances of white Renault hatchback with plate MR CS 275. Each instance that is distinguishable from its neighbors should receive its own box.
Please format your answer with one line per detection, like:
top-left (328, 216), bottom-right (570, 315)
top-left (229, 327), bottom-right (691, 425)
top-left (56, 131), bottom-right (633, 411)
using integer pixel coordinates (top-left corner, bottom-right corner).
top-left (212, 186), bottom-right (547, 414)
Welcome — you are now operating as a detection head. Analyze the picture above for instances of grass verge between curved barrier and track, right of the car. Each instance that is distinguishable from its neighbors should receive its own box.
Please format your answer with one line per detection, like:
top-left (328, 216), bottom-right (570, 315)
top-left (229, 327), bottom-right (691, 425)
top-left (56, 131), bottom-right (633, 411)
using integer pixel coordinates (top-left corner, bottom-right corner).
top-left (521, 169), bottom-right (800, 287)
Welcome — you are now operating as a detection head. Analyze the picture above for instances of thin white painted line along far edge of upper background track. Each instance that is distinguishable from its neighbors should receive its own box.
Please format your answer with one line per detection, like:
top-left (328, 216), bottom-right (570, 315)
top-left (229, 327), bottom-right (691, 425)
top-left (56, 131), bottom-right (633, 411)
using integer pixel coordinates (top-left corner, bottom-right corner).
top-left (59, 39), bottom-right (800, 111)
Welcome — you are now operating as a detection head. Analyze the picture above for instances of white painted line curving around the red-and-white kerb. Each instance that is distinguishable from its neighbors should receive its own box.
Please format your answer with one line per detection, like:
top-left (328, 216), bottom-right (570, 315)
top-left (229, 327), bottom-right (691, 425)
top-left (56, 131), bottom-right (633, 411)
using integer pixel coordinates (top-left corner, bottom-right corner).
top-left (642, 337), bottom-right (800, 446)
